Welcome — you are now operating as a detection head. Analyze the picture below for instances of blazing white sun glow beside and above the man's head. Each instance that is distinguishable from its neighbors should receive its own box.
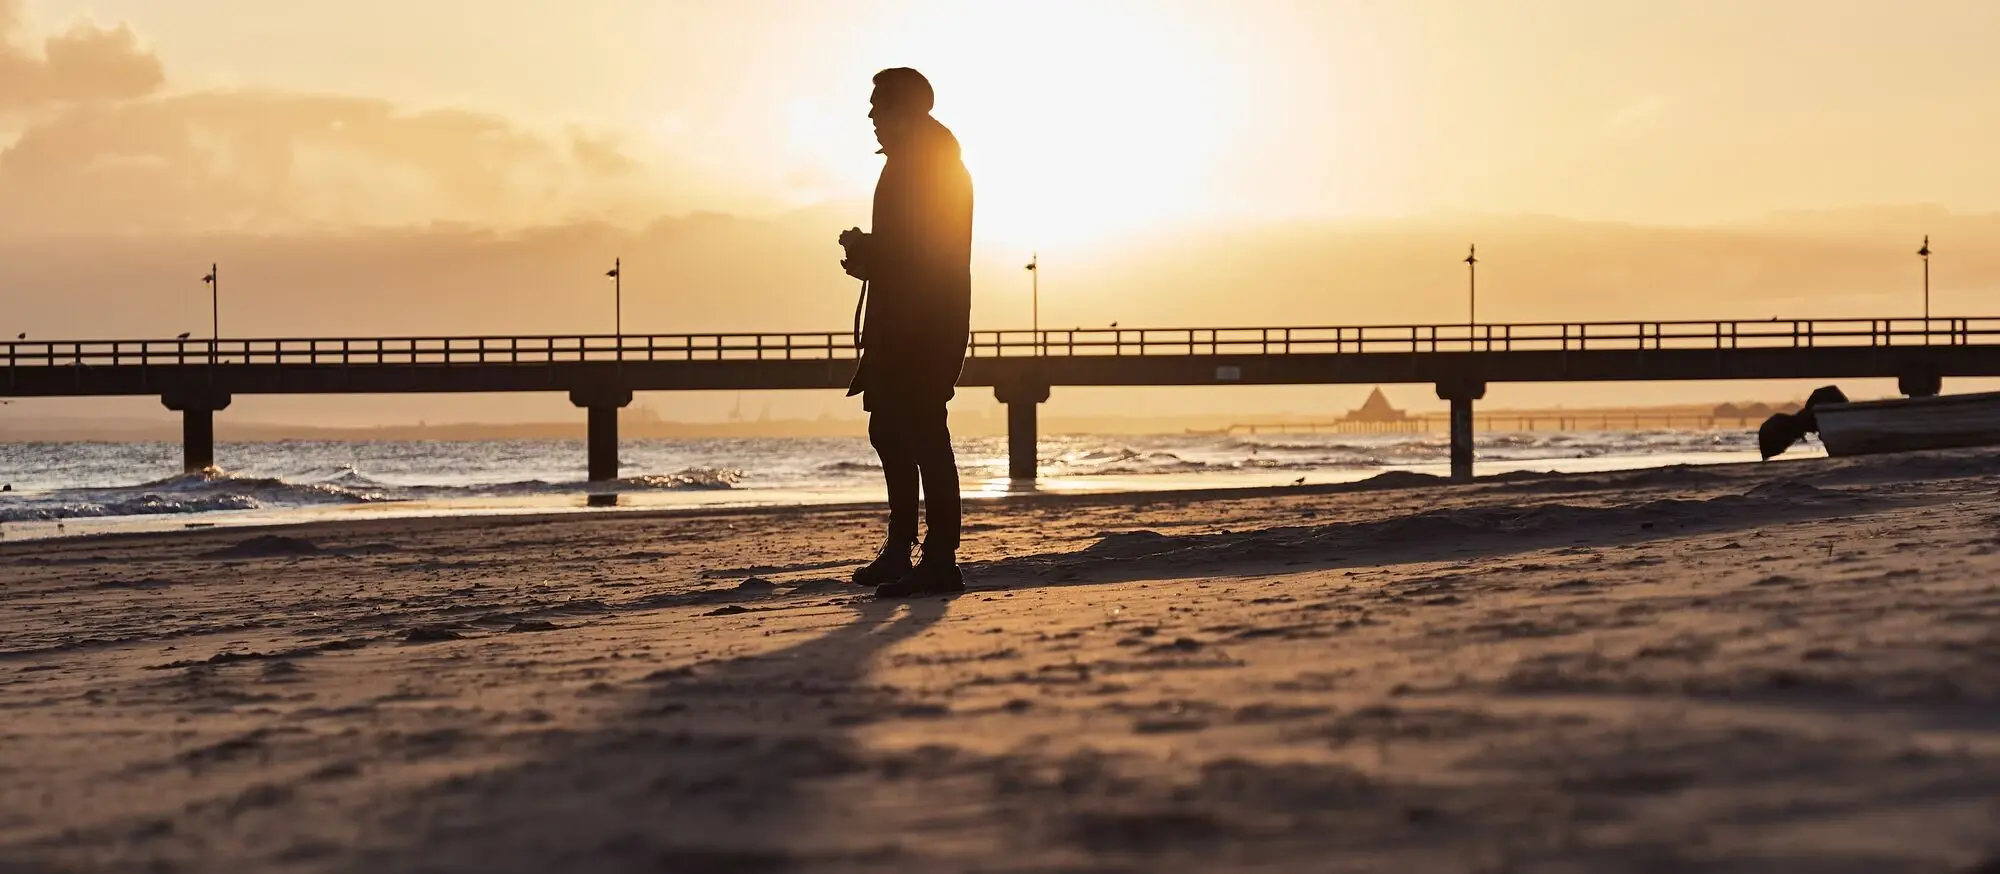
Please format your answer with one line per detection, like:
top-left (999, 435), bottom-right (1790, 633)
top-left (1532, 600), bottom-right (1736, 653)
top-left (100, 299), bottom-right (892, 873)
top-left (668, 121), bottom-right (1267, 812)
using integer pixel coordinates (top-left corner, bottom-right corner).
top-left (796, 2), bottom-right (1232, 250)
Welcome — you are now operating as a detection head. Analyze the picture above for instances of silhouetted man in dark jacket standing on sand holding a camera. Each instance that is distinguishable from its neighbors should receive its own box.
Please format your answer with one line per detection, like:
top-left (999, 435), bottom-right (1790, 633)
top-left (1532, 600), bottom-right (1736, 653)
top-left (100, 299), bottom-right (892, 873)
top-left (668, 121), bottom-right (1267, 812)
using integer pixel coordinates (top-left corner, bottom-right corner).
top-left (840, 68), bottom-right (972, 598)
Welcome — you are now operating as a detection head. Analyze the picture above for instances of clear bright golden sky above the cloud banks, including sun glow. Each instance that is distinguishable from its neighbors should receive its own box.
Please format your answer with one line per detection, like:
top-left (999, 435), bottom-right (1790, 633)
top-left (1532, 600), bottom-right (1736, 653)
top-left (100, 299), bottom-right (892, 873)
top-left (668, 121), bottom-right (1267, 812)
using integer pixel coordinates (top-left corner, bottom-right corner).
top-left (15, 0), bottom-right (2000, 236)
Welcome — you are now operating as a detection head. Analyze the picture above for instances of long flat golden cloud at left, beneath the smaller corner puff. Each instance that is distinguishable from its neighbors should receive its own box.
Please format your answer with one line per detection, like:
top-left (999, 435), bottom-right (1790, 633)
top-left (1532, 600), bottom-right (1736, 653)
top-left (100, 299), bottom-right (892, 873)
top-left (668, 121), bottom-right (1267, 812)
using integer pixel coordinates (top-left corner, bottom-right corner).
top-left (0, 92), bottom-right (696, 232)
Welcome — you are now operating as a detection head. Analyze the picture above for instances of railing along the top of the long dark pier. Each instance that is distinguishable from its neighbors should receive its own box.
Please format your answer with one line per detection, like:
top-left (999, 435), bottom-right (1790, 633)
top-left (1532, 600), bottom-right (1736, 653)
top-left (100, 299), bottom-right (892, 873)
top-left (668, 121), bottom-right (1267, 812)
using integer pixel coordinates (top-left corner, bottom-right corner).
top-left (0, 316), bottom-right (2000, 368)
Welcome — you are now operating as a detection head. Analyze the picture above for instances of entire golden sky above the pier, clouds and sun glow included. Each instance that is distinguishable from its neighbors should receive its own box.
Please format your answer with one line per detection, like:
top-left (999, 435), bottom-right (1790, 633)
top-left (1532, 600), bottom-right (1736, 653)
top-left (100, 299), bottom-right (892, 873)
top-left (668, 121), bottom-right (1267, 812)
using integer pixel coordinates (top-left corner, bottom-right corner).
top-left (0, 0), bottom-right (2000, 422)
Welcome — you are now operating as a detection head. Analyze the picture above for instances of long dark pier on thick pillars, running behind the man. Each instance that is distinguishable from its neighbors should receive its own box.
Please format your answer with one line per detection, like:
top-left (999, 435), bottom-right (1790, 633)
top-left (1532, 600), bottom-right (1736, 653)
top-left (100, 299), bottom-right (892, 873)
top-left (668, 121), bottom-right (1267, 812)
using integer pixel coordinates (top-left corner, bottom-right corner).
top-left (0, 316), bottom-right (2000, 480)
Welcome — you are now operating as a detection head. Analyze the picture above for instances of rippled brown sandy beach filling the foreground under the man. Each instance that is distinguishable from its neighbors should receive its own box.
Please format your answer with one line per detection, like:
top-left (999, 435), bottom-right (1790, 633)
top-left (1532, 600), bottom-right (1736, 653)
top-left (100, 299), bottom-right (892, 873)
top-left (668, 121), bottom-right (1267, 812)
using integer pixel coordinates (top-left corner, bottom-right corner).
top-left (0, 452), bottom-right (2000, 874)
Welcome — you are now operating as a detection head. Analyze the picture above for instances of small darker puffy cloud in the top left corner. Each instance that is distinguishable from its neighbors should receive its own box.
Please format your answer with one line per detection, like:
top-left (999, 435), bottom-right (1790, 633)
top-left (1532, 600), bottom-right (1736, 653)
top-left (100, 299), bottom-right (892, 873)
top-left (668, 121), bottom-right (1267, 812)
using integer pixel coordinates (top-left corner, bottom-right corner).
top-left (0, 0), bottom-right (166, 114)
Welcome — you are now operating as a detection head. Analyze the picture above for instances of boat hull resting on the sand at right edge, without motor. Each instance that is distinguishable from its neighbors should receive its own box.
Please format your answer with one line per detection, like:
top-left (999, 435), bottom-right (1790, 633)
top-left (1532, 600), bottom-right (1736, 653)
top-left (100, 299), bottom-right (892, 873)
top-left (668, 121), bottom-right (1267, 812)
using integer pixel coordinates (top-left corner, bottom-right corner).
top-left (1812, 392), bottom-right (2000, 456)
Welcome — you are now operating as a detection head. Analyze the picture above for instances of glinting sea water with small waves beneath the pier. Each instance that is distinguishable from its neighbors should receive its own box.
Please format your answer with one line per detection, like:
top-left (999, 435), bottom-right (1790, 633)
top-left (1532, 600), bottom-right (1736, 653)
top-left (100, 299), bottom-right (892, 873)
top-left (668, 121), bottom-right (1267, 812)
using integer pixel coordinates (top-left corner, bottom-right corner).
top-left (0, 430), bottom-right (1810, 540)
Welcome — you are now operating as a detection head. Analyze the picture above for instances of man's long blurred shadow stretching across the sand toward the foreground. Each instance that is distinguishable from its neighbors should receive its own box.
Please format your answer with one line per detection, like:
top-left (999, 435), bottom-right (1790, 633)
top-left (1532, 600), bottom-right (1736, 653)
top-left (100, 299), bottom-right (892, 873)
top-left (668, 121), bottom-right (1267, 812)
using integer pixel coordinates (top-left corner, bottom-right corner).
top-left (348, 598), bottom-right (950, 874)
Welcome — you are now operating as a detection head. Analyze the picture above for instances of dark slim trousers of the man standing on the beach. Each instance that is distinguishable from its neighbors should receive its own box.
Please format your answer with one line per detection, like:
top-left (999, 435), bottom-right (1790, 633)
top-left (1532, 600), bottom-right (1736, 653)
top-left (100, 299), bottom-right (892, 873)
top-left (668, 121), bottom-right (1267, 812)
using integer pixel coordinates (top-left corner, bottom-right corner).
top-left (868, 402), bottom-right (958, 556)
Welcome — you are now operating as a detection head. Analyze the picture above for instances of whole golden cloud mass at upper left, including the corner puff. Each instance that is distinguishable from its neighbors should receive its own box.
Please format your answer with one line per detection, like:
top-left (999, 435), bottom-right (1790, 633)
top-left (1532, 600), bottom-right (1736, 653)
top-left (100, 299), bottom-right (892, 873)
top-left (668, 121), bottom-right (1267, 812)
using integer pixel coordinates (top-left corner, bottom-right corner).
top-left (0, 0), bottom-right (734, 234)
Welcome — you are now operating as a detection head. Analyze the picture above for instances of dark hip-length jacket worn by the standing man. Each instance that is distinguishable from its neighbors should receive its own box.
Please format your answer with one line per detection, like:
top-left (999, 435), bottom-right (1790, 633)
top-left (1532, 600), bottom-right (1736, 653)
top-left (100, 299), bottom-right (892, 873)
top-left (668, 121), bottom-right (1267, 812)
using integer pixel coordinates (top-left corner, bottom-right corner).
top-left (848, 118), bottom-right (972, 410)
